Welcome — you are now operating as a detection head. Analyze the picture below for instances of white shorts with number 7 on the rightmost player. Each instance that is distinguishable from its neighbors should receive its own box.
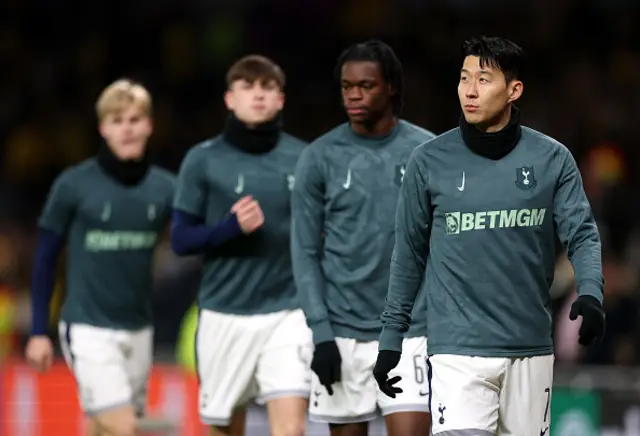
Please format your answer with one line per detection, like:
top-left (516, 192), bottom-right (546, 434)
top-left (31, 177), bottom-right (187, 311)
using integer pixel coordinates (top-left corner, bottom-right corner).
top-left (429, 354), bottom-right (554, 436)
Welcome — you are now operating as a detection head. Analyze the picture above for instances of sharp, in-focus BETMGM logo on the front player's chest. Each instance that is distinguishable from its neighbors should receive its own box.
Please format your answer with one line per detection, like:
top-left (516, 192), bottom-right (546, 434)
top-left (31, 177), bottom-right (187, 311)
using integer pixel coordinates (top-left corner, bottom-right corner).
top-left (444, 208), bottom-right (547, 235)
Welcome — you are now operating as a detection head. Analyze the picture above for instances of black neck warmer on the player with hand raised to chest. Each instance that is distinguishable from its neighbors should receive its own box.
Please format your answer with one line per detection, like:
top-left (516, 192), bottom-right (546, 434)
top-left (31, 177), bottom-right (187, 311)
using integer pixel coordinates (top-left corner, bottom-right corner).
top-left (222, 113), bottom-right (282, 154)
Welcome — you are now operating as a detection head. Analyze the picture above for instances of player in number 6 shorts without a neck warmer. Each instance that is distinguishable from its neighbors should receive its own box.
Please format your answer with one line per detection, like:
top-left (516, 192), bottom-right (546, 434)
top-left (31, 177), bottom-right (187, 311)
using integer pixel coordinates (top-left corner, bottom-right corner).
top-left (292, 41), bottom-right (434, 436)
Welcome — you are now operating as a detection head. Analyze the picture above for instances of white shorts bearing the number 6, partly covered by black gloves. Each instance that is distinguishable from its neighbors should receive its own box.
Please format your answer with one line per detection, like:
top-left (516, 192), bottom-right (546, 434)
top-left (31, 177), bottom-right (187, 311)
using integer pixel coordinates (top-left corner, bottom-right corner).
top-left (309, 337), bottom-right (429, 424)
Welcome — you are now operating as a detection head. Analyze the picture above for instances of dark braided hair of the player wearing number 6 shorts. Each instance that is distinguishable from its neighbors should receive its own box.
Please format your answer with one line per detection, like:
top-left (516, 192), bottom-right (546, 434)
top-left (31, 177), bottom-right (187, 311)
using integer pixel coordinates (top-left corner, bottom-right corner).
top-left (334, 39), bottom-right (404, 115)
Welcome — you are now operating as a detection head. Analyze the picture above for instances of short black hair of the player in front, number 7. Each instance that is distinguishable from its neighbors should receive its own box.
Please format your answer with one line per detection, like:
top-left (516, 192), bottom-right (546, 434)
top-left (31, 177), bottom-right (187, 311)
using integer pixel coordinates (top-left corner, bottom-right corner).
top-left (462, 36), bottom-right (524, 83)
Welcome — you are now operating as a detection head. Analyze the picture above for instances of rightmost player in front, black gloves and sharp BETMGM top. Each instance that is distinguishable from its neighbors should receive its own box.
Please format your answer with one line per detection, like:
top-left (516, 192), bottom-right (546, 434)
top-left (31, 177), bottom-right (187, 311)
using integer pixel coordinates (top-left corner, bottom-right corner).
top-left (375, 37), bottom-right (605, 436)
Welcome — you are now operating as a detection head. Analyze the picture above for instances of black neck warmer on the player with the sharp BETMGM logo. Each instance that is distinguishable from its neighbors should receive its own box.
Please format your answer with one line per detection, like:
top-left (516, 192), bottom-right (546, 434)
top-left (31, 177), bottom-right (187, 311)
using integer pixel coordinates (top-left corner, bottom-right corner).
top-left (460, 106), bottom-right (522, 160)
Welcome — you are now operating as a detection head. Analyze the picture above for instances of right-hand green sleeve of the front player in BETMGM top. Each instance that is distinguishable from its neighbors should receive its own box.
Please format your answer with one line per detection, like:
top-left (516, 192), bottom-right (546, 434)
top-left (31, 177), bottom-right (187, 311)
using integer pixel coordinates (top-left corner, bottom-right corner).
top-left (553, 151), bottom-right (604, 302)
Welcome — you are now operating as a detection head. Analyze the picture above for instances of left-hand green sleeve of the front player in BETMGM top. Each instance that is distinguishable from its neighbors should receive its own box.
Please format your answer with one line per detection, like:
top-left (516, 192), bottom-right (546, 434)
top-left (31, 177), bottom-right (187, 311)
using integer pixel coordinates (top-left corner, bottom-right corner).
top-left (379, 147), bottom-right (431, 352)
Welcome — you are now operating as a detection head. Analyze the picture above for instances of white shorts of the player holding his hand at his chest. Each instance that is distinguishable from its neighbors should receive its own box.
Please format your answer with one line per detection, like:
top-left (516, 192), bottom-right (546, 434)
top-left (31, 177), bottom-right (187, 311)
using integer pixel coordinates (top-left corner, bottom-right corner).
top-left (196, 309), bottom-right (313, 426)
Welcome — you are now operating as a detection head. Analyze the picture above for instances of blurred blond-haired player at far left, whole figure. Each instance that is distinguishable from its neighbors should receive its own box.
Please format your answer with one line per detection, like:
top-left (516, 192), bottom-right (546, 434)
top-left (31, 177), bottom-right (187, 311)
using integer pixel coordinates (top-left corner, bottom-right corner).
top-left (26, 79), bottom-right (175, 436)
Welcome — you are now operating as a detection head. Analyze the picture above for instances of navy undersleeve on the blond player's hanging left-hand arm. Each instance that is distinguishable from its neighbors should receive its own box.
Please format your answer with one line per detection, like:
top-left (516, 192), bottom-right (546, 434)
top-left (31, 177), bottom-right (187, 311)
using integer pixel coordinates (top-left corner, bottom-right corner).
top-left (31, 229), bottom-right (65, 335)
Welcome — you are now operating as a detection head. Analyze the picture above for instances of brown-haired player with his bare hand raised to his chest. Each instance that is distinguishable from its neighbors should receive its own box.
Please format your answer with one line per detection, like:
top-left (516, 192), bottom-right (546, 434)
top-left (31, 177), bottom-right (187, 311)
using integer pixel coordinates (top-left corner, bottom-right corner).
top-left (171, 56), bottom-right (312, 436)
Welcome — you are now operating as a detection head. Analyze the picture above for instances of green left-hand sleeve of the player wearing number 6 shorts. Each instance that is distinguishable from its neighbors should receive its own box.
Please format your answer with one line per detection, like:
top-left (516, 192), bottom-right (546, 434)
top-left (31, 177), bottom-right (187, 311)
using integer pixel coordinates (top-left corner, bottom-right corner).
top-left (291, 147), bottom-right (334, 344)
